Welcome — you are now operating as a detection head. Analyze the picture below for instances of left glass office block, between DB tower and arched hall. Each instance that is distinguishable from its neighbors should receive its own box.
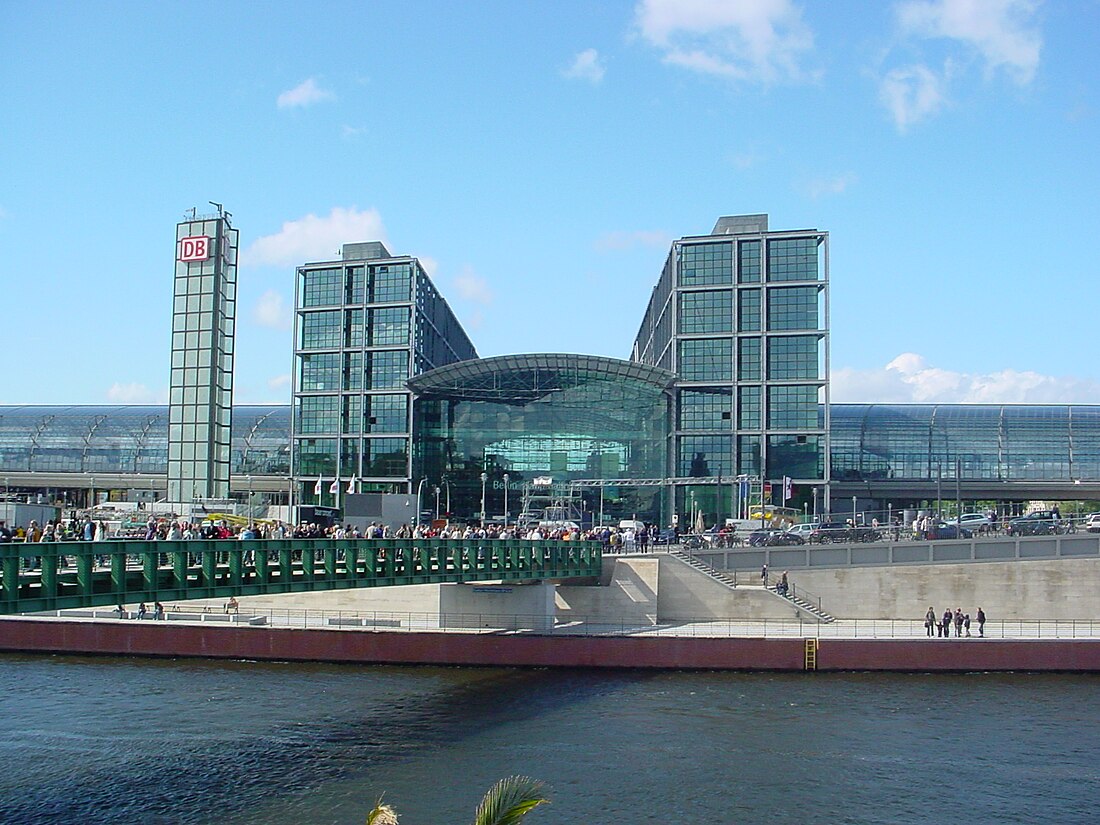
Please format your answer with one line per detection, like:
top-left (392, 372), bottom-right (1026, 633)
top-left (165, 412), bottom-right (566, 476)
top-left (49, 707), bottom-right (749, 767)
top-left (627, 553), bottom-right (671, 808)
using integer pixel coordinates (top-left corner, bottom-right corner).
top-left (292, 242), bottom-right (477, 506)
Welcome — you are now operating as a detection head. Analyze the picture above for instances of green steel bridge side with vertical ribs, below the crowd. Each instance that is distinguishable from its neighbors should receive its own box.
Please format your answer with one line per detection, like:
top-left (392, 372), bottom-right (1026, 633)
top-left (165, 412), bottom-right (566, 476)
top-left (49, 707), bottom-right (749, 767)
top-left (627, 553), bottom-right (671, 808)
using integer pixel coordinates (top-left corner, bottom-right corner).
top-left (0, 539), bottom-right (603, 614)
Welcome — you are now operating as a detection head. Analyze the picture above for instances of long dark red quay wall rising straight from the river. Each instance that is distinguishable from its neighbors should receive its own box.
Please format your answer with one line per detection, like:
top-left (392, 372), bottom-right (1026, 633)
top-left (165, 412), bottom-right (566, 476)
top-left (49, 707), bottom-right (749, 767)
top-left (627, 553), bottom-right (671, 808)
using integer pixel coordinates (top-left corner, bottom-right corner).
top-left (0, 618), bottom-right (1100, 672)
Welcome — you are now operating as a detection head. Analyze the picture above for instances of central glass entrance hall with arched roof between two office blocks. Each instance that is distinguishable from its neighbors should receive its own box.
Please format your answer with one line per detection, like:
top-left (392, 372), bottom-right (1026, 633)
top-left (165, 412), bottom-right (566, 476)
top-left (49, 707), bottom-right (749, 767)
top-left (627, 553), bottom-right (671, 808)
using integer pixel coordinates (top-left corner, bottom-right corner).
top-left (409, 354), bottom-right (675, 521)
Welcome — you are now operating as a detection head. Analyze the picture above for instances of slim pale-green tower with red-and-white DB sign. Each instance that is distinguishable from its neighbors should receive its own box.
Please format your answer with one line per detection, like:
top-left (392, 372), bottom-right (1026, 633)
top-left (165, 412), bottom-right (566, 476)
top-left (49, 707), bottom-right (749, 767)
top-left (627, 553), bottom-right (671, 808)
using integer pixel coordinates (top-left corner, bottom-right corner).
top-left (167, 207), bottom-right (238, 503)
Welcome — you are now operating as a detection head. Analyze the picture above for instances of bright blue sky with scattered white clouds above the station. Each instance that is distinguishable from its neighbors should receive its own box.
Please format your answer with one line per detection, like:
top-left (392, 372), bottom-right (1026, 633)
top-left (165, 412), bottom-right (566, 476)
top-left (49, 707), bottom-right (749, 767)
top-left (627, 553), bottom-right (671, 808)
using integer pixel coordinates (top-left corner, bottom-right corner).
top-left (0, 0), bottom-right (1100, 404)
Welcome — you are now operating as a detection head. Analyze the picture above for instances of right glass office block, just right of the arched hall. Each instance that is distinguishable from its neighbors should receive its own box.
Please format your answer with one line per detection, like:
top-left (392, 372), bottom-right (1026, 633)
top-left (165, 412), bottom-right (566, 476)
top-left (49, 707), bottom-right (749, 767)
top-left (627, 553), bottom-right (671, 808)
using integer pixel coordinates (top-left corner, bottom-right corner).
top-left (631, 215), bottom-right (828, 523)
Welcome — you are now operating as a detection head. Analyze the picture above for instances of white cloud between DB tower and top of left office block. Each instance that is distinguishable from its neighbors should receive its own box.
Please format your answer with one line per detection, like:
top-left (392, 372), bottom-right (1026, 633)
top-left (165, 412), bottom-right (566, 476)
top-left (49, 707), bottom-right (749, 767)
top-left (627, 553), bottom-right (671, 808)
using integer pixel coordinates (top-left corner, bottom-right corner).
top-left (241, 207), bottom-right (386, 266)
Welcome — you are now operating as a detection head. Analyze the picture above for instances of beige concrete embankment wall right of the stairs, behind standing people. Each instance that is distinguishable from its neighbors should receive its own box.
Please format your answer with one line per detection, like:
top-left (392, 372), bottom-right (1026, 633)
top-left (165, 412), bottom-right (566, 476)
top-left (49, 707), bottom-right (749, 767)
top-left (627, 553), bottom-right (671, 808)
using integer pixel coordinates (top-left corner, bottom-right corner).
top-left (787, 559), bottom-right (1100, 622)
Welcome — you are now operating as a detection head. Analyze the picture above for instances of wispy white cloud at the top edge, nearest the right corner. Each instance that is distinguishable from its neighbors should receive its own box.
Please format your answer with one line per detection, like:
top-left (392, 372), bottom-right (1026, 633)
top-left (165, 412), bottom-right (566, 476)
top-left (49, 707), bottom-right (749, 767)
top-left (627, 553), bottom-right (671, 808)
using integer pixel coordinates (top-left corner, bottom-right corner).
top-left (897, 0), bottom-right (1043, 84)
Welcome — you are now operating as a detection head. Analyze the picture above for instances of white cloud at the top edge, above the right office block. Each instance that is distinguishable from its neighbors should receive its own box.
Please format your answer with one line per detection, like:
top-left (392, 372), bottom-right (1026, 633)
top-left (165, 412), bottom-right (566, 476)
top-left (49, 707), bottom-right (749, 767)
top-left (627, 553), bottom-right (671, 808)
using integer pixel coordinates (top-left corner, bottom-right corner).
top-left (635, 0), bottom-right (814, 83)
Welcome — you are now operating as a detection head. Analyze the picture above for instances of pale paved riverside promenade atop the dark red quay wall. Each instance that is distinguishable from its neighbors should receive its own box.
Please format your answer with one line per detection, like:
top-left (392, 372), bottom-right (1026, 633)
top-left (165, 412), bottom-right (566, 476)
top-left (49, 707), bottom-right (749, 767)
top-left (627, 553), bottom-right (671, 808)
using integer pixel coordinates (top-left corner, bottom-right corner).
top-left (23, 605), bottom-right (1100, 645)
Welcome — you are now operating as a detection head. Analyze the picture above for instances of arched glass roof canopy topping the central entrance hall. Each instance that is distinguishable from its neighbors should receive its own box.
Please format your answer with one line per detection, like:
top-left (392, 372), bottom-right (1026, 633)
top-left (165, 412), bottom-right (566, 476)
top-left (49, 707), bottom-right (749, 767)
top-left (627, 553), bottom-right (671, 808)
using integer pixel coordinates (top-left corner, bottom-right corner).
top-left (408, 353), bottom-right (675, 405)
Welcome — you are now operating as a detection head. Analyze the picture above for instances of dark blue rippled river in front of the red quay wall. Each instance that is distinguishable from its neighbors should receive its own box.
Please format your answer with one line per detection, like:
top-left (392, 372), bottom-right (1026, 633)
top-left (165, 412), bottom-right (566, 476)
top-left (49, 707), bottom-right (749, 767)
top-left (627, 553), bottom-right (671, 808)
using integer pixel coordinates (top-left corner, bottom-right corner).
top-left (0, 655), bottom-right (1100, 825)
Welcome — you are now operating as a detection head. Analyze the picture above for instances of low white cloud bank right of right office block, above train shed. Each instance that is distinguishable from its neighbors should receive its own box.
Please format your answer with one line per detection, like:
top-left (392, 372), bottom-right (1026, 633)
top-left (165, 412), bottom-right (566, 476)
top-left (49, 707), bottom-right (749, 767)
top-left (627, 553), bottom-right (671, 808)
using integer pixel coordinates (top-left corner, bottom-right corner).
top-left (832, 352), bottom-right (1100, 404)
